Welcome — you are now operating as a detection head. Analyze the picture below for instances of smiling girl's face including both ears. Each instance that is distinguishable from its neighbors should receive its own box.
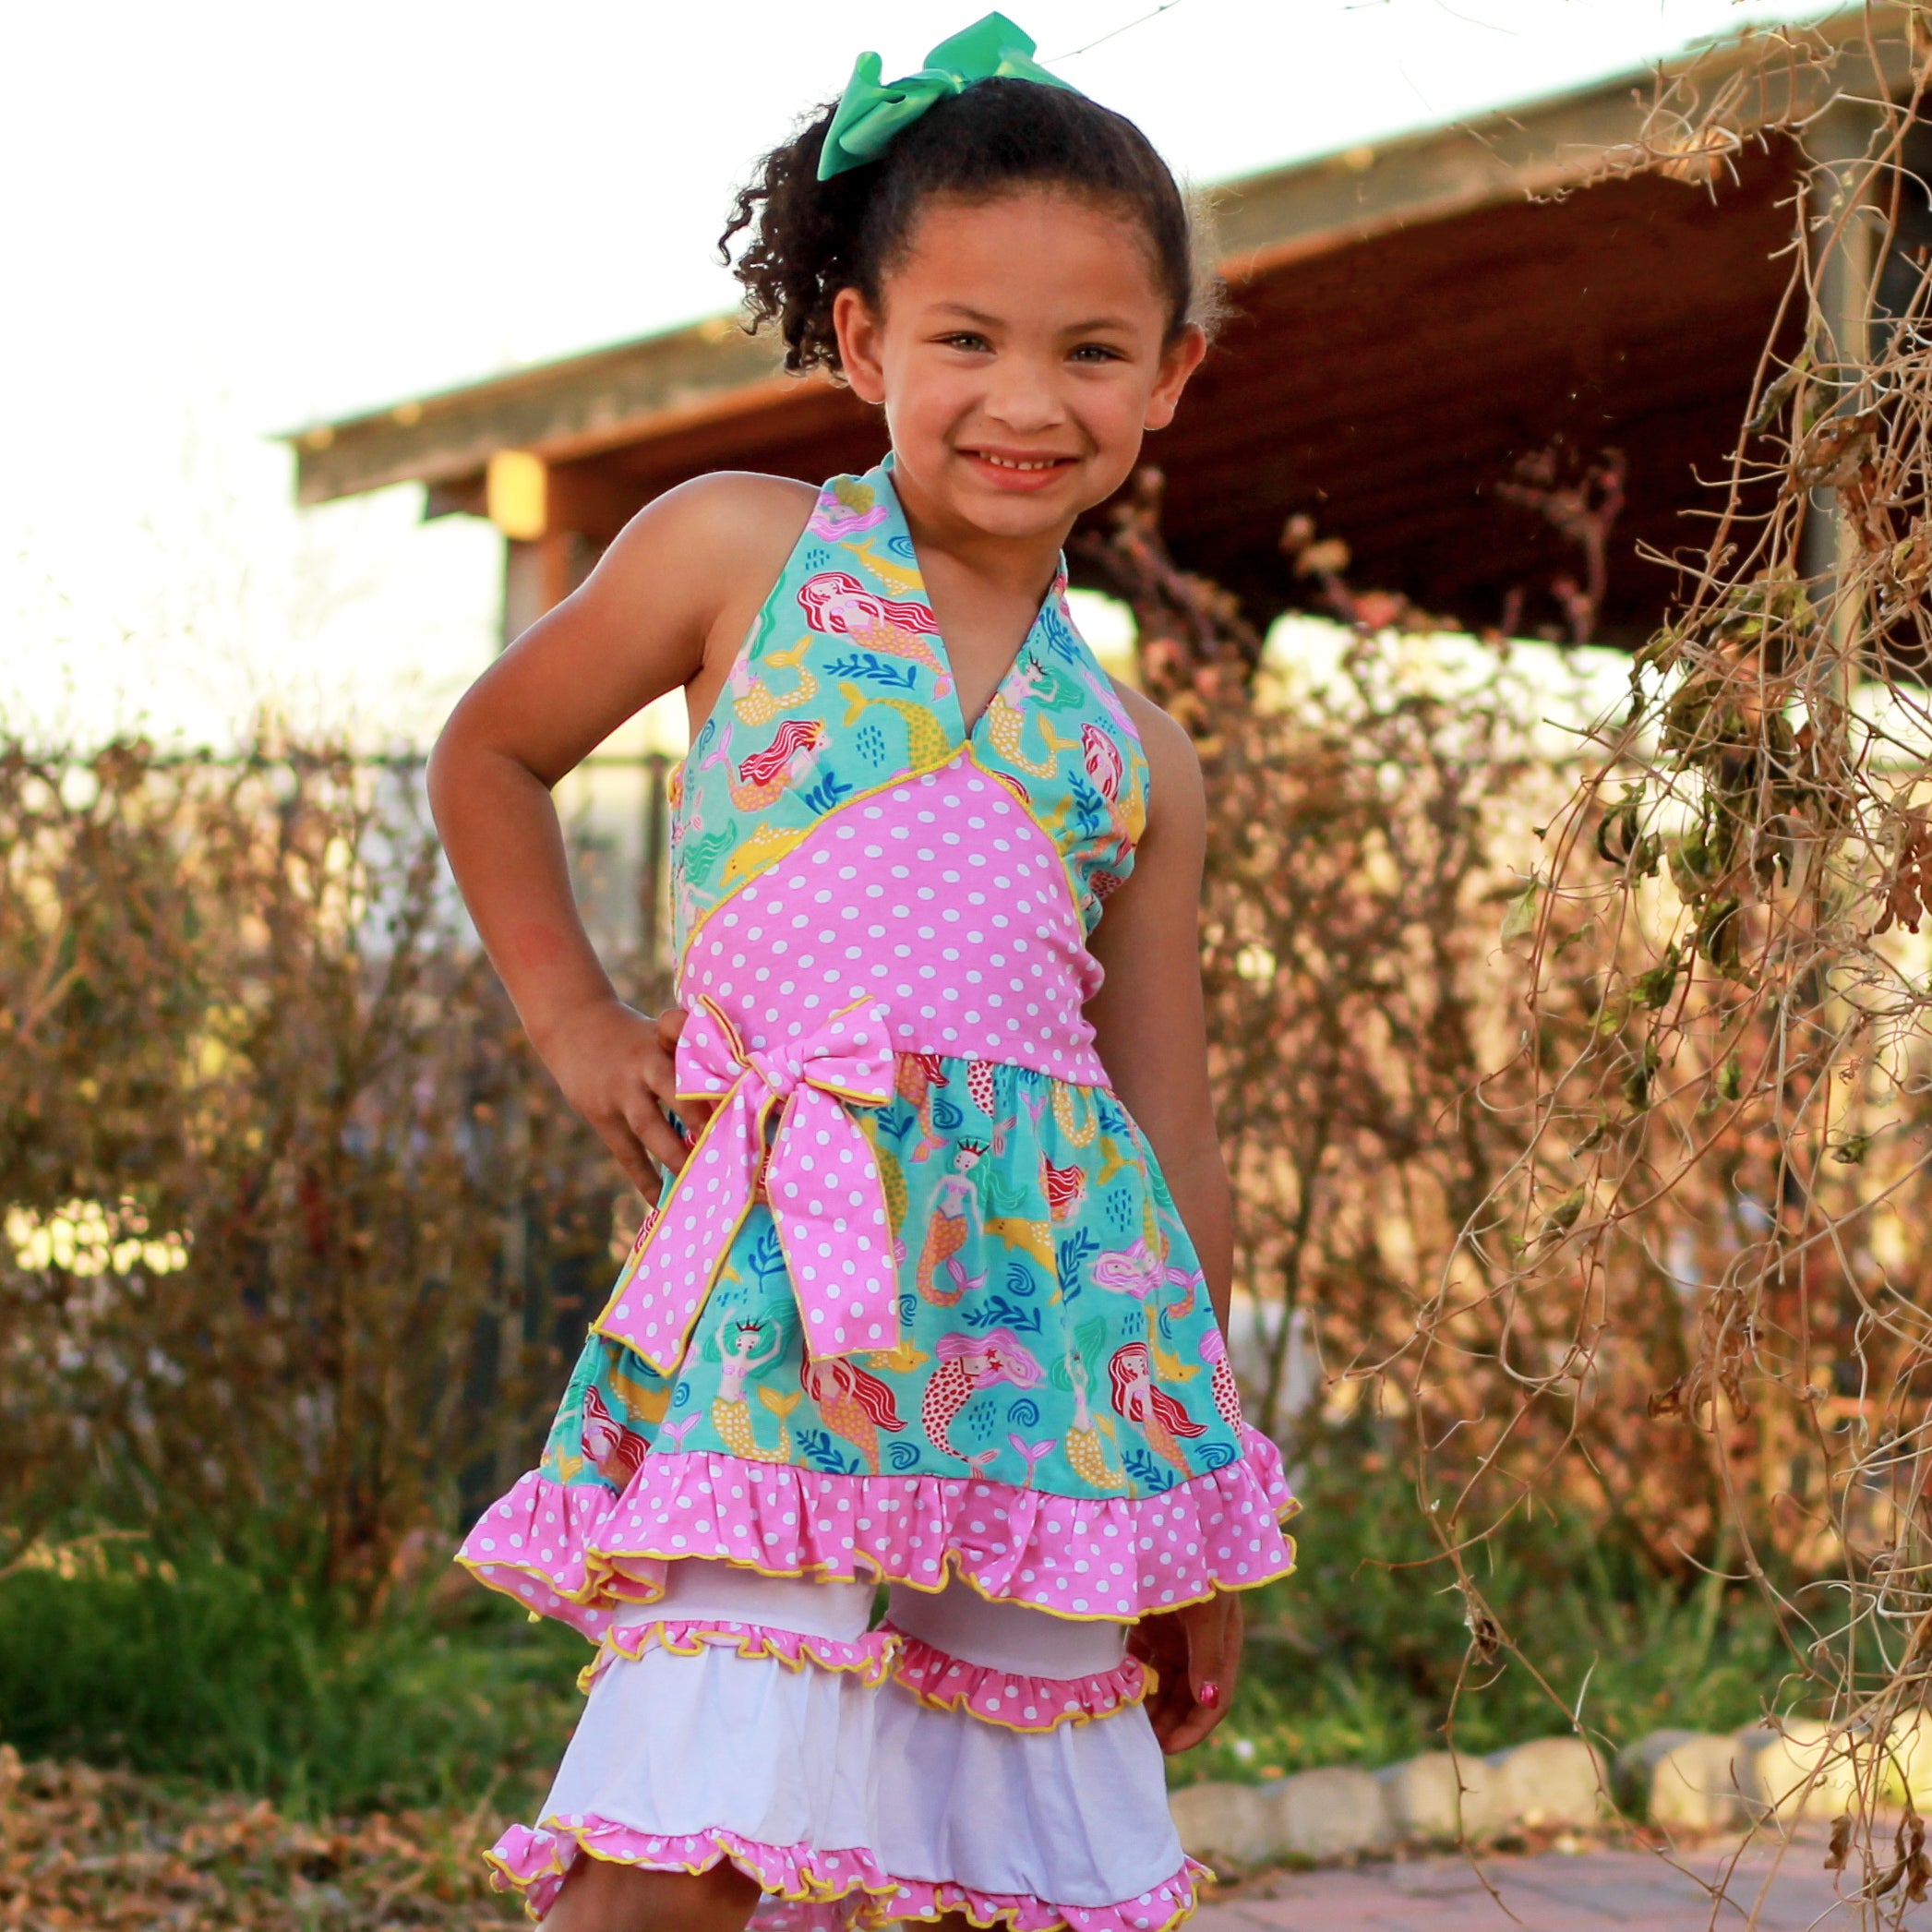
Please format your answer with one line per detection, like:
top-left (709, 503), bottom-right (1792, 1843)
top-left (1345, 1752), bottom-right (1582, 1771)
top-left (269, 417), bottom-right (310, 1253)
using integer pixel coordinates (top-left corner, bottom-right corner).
top-left (833, 189), bottom-right (1206, 539)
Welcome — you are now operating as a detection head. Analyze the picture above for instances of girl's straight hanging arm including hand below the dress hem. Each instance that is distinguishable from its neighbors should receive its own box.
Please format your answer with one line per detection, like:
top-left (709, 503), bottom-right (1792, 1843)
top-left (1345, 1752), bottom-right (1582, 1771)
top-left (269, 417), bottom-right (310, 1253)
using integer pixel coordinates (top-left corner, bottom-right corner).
top-left (1086, 688), bottom-right (1241, 1754)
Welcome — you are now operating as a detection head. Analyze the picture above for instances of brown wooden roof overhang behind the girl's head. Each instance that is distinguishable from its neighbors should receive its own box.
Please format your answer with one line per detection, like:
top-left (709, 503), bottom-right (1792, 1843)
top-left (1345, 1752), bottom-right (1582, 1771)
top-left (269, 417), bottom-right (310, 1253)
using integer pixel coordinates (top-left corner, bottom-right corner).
top-left (290, 14), bottom-right (1895, 642)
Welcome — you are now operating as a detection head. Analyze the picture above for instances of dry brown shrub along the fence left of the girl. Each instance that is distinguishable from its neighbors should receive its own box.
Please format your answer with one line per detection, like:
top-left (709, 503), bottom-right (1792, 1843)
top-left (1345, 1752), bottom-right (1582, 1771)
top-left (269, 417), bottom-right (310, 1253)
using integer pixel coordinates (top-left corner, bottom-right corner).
top-left (0, 738), bottom-right (612, 1605)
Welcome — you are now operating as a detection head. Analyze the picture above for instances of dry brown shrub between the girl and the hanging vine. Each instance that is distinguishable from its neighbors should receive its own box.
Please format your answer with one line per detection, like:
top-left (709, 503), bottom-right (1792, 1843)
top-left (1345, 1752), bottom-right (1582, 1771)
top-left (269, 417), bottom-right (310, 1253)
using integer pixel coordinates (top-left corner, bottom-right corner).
top-left (1086, 474), bottom-right (1718, 1578)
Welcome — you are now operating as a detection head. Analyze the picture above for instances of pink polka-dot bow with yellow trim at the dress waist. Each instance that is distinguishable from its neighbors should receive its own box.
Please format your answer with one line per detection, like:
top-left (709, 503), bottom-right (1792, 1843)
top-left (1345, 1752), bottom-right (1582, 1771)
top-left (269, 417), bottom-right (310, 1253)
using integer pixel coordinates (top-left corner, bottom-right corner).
top-left (597, 999), bottom-right (898, 1375)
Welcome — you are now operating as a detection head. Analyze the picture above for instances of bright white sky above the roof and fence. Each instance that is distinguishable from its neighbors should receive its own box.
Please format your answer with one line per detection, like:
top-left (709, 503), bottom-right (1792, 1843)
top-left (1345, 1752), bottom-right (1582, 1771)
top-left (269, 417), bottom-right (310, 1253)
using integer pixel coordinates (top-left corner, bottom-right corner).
top-left (0, 0), bottom-right (1820, 742)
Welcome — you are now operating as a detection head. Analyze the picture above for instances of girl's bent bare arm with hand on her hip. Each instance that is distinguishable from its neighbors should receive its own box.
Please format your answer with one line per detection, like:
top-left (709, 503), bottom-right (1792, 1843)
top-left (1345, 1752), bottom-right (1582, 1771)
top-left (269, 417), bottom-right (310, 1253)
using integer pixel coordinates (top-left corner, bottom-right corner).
top-left (429, 475), bottom-right (813, 1196)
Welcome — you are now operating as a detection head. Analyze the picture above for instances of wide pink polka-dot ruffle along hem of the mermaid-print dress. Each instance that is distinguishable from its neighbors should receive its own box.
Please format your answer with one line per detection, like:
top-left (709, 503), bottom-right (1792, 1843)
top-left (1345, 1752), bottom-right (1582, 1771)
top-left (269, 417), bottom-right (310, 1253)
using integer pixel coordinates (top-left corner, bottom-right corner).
top-left (458, 1428), bottom-right (1296, 1640)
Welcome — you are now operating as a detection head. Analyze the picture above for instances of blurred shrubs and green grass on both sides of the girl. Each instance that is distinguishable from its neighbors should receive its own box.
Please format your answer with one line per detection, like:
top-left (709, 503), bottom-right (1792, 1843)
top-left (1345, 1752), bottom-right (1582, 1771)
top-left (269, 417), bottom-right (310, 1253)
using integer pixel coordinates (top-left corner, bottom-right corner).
top-left (0, 618), bottom-right (1803, 1814)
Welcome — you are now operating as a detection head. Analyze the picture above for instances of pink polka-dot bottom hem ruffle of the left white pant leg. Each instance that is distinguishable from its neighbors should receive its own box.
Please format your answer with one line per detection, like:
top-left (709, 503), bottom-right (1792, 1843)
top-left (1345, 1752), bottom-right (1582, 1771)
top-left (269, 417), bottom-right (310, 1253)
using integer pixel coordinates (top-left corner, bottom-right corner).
top-left (483, 1816), bottom-right (898, 1923)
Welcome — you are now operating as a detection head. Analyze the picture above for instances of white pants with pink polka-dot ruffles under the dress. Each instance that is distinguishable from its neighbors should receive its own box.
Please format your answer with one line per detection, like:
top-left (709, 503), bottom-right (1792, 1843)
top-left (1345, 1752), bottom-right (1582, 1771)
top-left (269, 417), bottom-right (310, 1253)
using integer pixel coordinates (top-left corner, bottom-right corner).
top-left (491, 1559), bottom-right (1202, 1932)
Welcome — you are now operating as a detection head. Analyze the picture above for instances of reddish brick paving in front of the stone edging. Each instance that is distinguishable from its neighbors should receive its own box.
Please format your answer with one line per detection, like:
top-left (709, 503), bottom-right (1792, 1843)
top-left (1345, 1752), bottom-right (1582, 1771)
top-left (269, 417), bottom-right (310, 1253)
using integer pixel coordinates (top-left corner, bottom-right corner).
top-left (1190, 1835), bottom-right (1893, 1932)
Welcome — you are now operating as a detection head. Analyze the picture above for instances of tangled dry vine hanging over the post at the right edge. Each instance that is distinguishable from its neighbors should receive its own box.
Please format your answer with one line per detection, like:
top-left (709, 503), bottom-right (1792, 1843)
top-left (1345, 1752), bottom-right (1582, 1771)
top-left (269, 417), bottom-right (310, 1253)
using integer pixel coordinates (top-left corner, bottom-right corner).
top-left (1407, 6), bottom-right (1932, 1923)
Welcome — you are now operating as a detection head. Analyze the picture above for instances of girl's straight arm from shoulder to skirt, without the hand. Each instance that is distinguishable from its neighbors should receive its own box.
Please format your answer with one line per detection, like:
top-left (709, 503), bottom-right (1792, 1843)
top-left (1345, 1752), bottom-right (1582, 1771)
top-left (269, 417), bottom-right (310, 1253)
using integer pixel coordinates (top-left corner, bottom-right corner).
top-left (1086, 686), bottom-right (1234, 1329)
